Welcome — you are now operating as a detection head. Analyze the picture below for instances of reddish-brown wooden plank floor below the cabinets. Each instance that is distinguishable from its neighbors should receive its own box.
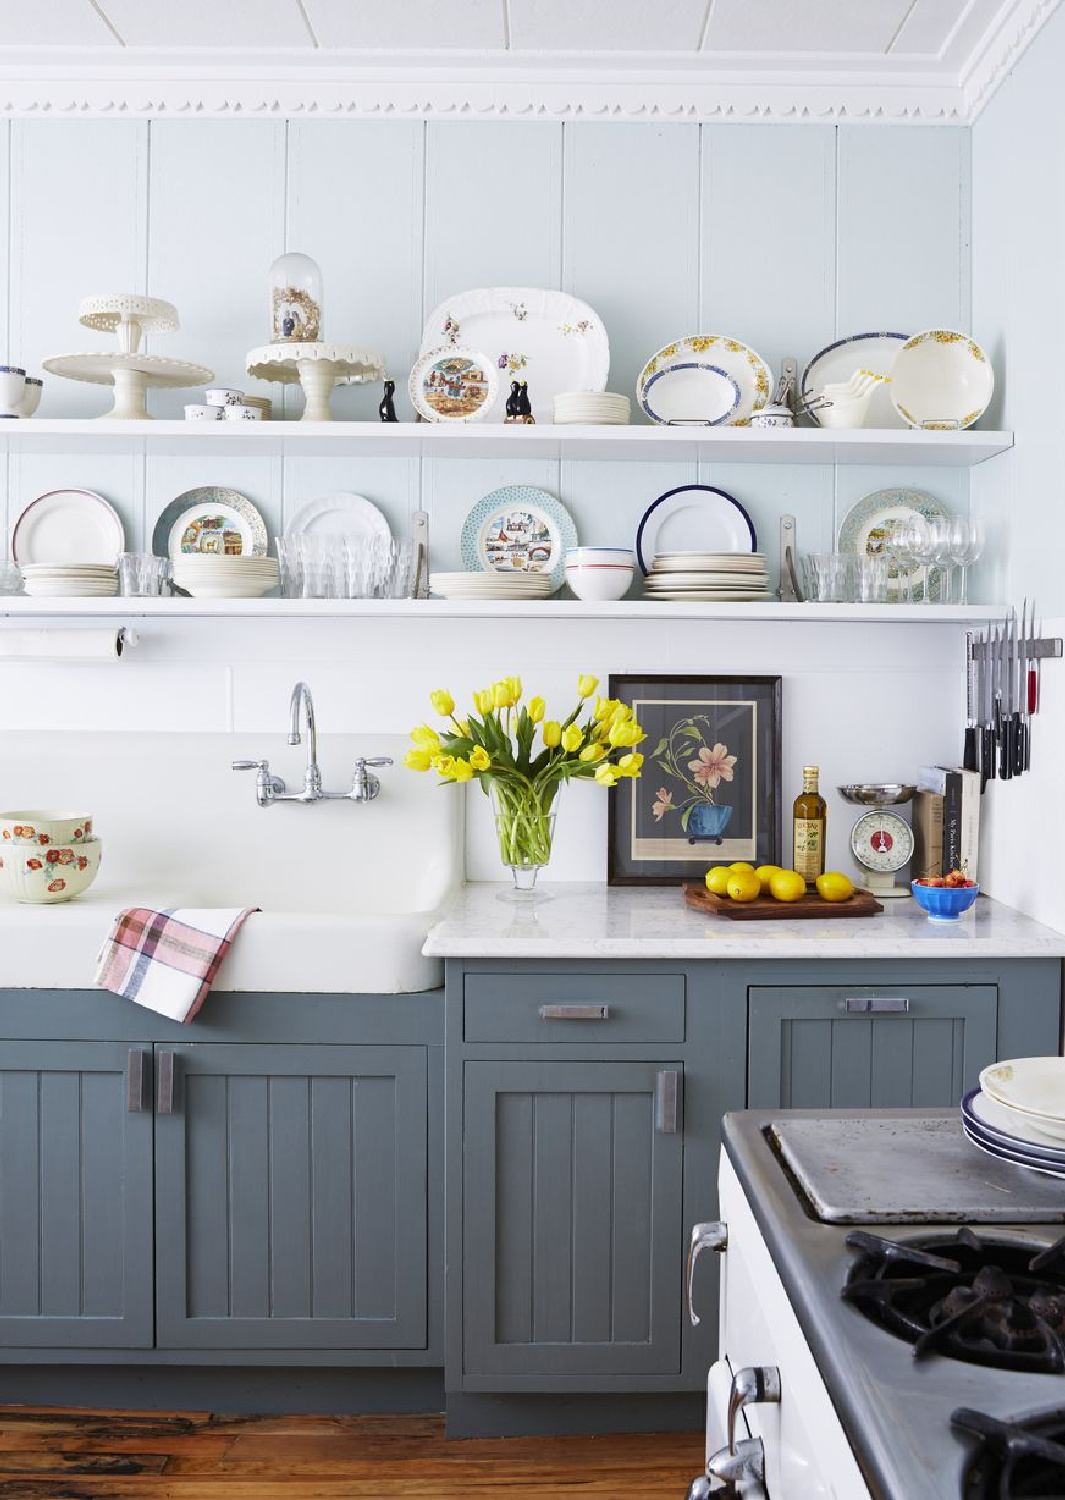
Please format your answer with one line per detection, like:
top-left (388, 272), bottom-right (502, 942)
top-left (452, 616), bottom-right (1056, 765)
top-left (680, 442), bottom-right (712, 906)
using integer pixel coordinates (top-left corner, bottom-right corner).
top-left (0, 1407), bottom-right (702, 1500)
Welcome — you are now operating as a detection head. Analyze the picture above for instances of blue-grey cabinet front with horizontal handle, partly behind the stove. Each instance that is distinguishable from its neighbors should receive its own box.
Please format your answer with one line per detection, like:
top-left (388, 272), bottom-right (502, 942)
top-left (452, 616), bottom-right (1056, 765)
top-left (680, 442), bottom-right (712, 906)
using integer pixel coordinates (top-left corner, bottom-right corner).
top-left (747, 981), bottom-right (999, 1110)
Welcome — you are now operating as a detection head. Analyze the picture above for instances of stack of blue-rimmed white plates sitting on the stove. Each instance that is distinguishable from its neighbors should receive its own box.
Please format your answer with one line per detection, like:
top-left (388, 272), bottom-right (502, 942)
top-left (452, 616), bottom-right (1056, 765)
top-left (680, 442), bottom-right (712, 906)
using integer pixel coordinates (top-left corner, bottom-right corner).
top-left (962, 1058), bottom-right (1065, 1178)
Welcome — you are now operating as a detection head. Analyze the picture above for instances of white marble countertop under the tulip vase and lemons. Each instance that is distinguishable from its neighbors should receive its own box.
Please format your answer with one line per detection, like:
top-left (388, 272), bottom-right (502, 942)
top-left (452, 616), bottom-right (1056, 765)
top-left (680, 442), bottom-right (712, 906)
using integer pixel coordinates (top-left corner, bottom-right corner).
top-left (423, 884), bottom-right (1065, 959)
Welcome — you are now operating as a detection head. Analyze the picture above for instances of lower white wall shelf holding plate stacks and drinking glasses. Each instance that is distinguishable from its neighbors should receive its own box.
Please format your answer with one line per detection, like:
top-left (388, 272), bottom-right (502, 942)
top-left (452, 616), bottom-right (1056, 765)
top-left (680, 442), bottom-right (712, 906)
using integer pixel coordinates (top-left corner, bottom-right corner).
top-left (0, 596), bottom-right (1007, 626)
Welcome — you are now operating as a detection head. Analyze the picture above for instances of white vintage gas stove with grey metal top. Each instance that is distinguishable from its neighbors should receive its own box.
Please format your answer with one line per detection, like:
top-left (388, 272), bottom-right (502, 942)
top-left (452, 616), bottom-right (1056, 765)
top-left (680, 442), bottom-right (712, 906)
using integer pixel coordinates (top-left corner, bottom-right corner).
top-left (689, 1112), bottom-right (1065, 1500)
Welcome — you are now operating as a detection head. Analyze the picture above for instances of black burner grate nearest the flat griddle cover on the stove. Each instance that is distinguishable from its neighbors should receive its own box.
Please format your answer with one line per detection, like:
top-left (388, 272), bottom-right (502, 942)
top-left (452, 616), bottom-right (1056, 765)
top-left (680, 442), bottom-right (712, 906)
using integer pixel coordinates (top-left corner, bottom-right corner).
top-left (842, 1229), bottom-right (1065, 1374)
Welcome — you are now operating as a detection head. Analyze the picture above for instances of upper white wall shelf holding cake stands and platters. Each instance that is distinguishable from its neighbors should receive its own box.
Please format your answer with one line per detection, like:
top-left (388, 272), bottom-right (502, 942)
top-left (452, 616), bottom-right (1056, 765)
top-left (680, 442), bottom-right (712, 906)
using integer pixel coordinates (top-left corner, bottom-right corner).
top-left (0, 417), bottom-right (1013, 468)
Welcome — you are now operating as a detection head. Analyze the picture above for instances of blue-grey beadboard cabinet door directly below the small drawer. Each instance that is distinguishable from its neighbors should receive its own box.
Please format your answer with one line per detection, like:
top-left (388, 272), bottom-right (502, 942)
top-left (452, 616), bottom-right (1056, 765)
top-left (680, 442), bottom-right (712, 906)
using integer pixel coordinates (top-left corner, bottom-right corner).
top-left (462, 1061), bottom-right (683, 1391)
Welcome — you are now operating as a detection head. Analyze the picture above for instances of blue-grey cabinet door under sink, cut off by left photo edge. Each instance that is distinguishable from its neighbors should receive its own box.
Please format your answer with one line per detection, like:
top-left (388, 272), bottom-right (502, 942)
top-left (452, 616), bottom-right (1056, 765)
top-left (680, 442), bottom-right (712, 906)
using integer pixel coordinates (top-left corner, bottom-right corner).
top-left (0, 1041), bottom-right (153, 1349)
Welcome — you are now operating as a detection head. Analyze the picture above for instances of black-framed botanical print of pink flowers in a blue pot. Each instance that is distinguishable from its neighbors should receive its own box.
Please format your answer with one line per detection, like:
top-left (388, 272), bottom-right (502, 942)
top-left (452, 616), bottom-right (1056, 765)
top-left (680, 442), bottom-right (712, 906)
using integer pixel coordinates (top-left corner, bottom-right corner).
top-left (609, 674), bottom-right (780, 885)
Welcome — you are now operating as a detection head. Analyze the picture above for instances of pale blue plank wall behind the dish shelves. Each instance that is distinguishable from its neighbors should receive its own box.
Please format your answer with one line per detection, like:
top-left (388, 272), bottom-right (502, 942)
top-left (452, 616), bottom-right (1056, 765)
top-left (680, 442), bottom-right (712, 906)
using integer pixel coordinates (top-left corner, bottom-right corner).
top-left (0, 111), bottom-right (980, 567)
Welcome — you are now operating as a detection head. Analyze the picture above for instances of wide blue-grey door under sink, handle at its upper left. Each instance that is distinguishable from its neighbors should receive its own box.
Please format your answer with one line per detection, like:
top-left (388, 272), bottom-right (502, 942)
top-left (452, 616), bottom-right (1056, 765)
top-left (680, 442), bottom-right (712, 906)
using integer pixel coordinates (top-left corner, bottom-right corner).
top-left (156, 1044), bottom-right (428, 1350)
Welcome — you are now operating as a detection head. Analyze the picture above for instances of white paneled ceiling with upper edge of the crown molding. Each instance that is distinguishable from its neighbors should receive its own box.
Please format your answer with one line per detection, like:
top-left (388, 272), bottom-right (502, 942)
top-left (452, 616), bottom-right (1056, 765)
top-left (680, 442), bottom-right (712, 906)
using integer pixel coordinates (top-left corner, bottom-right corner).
top-left (0, 0), bottom-right (1058, 119)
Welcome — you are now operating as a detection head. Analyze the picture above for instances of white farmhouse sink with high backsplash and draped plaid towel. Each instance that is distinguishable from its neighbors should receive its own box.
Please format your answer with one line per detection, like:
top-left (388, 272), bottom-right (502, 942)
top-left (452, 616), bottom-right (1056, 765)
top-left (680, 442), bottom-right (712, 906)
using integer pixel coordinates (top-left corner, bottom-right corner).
top-left (0, 734), bottom-right (462, 995)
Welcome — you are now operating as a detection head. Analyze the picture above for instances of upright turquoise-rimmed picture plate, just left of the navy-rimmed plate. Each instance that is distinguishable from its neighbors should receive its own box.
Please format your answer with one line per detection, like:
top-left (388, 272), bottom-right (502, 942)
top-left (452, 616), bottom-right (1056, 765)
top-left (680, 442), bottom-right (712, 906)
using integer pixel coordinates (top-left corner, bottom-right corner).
top-left (462, 485), bottom-right (578, 588)
